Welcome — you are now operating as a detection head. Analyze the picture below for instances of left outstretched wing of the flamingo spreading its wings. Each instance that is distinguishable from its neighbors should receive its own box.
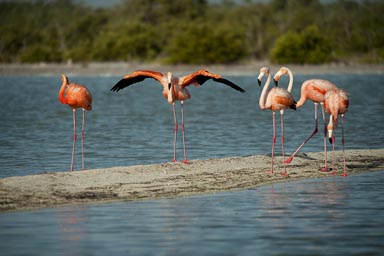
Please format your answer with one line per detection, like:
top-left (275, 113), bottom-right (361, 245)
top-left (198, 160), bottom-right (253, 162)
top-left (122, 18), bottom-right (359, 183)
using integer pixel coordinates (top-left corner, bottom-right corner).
top-left (111, 70), bottom-right (164, 92)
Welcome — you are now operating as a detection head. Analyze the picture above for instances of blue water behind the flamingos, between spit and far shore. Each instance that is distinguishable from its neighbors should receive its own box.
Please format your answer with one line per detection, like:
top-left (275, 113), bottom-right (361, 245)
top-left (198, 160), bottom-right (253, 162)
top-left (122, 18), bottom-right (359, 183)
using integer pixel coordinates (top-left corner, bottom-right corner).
top-left (0, 75), bottom-right (384, 177)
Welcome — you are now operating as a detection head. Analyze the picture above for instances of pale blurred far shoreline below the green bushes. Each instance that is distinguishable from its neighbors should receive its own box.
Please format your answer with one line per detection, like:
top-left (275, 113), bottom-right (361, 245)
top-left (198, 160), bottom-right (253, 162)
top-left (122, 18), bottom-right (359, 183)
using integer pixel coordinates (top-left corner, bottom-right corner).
top-left (0, 61), bottom-right (384, 77)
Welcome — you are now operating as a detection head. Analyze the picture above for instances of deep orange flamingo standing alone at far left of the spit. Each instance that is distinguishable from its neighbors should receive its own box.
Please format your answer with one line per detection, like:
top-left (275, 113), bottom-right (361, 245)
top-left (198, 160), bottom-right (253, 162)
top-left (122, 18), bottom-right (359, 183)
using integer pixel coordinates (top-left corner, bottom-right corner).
top-left (59, 74), bottom-right (92, 172)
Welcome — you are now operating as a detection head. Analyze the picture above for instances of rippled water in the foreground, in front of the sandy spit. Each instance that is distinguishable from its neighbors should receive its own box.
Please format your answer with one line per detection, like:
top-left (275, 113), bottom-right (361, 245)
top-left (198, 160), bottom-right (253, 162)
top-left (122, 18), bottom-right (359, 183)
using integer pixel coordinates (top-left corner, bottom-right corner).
top-left (0, 171), bottom-right (384, 256)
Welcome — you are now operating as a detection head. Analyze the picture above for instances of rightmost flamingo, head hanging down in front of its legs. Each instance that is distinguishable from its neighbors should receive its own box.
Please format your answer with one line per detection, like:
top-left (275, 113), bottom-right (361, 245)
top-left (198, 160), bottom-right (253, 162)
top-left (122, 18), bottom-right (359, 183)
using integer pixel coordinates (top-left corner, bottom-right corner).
top-left (324, 89), bottom-right (349, 176)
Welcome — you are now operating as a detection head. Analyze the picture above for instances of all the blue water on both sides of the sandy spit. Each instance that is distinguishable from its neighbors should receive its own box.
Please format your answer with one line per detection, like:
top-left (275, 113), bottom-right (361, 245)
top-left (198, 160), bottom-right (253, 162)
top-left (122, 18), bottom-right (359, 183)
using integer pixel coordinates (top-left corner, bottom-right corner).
top-left (0, 74), bottom-right (384, 255)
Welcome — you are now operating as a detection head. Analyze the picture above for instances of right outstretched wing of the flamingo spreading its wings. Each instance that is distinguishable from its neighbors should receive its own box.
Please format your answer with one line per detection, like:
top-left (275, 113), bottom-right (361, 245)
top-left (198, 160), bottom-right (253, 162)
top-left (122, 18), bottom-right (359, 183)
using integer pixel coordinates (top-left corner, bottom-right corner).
top-left (181, 69), bottom-right (245, 92)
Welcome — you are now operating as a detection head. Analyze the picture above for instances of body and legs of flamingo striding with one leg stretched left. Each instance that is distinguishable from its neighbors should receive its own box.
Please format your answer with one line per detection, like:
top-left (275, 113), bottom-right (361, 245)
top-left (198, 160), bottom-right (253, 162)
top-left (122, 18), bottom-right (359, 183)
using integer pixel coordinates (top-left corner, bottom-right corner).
top-left (285, 79), bottom-right (337, 171)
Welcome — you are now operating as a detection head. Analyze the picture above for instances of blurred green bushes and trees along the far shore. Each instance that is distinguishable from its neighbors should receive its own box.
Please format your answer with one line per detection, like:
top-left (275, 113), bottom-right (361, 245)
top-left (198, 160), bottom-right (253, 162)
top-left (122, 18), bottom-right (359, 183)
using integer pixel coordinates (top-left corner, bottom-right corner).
top-left (0, 0), bottom-right (384, 64)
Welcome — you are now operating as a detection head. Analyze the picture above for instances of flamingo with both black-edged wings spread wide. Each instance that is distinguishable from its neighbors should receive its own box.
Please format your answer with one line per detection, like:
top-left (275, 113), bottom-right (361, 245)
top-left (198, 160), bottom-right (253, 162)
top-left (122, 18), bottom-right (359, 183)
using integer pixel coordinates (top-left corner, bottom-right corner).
top-left (111, 69), bottom-right (245, 164)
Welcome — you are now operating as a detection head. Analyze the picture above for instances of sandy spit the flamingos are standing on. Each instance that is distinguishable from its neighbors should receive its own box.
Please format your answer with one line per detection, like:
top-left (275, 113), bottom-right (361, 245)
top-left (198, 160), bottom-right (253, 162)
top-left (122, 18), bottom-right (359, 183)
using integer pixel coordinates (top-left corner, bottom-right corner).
top-left (0, 149), bottom-right (384, 212)
